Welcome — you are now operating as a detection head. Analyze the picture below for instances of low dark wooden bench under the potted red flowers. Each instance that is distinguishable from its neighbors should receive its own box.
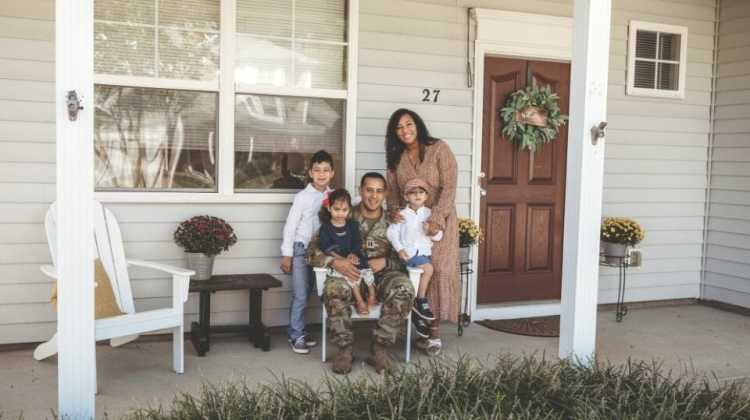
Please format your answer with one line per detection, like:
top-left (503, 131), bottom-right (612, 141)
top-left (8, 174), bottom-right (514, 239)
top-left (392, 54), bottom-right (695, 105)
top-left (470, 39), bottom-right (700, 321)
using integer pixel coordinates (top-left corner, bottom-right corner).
top-left (190, 273), bottom-right (281, 357)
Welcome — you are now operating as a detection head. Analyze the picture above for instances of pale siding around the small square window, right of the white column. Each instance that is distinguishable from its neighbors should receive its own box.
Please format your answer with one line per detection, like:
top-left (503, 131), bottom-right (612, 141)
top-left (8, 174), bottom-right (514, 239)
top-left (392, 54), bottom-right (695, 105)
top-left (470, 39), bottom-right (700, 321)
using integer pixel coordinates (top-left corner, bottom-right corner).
top-left (599, 0), bottom-right (715, 302)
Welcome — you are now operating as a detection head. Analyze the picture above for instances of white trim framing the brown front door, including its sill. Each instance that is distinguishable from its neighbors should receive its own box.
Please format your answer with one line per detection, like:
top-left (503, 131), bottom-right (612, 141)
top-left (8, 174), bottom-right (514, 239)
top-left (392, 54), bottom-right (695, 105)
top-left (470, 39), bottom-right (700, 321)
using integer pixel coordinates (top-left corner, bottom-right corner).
top-left (469, 9), bottom-right (573, 319)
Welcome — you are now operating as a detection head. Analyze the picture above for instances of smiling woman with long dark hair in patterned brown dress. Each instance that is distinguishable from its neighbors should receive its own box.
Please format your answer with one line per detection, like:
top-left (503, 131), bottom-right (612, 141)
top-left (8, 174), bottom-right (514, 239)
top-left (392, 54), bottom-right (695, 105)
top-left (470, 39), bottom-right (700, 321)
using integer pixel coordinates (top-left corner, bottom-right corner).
top-left (385, 109), bottom-right (460, 354)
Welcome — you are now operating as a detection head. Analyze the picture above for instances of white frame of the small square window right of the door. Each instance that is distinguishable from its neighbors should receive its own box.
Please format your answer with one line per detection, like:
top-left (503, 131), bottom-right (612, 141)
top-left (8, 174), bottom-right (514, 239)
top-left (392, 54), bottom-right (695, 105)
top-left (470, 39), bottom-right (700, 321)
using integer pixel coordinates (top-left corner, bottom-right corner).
top-left (627, 20), bottom-right (688, 99)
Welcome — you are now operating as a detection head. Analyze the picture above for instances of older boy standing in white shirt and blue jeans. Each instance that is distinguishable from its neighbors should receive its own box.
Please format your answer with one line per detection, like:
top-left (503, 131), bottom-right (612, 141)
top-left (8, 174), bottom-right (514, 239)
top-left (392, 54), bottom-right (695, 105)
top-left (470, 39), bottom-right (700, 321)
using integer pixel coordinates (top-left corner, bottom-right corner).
top-left (281, 150), bottom-right (334, 354)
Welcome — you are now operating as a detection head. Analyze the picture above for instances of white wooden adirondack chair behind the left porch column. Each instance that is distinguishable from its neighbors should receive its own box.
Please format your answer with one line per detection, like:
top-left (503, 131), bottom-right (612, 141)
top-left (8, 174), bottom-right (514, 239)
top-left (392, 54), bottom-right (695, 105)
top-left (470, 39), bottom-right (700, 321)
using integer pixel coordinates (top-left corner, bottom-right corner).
top-left (34, 201), bottom-right (195, 374)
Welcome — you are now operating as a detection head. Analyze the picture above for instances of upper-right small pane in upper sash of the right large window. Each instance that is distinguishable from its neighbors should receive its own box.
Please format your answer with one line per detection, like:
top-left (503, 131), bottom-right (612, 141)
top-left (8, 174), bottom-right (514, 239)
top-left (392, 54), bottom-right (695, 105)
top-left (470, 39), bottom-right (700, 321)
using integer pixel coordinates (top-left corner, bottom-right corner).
top-left (295, 0), bottom-right (346, 42)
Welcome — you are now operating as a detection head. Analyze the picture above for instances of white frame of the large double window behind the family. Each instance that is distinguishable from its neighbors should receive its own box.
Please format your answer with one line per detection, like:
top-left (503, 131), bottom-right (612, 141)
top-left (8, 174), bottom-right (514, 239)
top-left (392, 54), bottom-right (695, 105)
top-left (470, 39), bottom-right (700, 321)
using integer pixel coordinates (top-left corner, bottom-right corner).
top-left (93, 0), bottom-right (359, 203)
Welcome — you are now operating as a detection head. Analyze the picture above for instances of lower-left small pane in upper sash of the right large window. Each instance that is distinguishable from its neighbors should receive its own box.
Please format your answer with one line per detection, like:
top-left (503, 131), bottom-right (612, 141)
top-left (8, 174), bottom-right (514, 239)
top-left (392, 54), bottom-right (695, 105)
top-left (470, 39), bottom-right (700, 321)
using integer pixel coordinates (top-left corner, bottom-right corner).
top-left (235, 35), bottom-right (292, 86)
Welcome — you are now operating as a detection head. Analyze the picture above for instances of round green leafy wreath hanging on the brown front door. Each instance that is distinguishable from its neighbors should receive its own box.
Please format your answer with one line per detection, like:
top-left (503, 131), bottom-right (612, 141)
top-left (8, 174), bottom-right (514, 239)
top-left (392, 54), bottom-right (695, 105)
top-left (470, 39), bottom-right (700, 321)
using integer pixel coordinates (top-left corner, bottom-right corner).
top-left (498, 85), bottom-right (568, 152)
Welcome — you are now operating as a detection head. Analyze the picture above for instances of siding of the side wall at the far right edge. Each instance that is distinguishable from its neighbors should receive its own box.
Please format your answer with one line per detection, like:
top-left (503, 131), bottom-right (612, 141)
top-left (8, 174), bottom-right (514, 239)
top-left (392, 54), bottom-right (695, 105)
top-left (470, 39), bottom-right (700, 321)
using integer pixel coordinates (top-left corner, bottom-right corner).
top-left (703, 0), bottom-right (750, 307)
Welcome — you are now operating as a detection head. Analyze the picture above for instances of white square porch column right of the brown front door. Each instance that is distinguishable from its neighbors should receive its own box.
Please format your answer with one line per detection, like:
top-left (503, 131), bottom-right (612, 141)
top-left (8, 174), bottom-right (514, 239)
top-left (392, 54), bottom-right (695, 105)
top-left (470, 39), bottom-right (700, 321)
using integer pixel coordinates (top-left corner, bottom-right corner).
top-left (559, 0), bottom-right (611, 363)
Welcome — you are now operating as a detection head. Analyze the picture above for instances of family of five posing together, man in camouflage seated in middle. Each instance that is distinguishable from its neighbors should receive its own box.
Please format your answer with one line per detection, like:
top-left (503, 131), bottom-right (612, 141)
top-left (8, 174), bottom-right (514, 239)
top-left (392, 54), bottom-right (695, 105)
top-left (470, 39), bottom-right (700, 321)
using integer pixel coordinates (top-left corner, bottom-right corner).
top-left (281, 109), bottom-right (460, 374)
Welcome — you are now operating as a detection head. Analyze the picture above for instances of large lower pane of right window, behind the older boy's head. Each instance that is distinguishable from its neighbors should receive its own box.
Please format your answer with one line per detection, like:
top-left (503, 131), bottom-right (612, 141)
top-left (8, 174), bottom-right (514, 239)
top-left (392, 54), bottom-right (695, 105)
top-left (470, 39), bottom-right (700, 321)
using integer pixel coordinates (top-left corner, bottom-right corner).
top-left (234, 95), bottom-right (345, 190)
